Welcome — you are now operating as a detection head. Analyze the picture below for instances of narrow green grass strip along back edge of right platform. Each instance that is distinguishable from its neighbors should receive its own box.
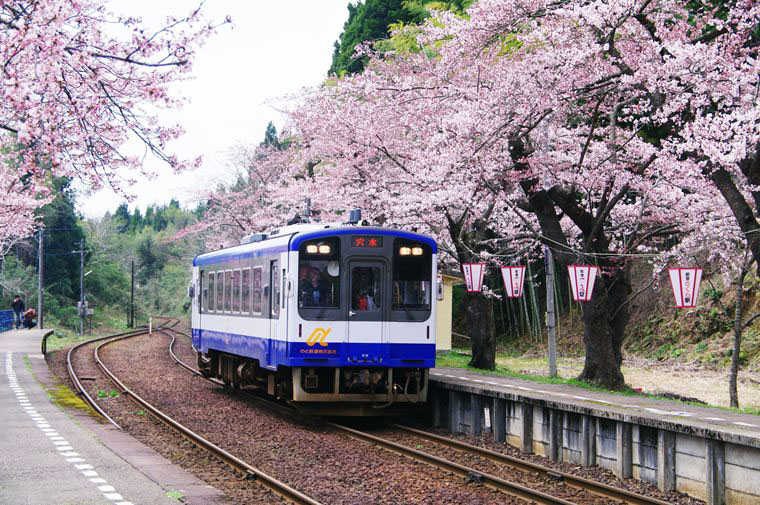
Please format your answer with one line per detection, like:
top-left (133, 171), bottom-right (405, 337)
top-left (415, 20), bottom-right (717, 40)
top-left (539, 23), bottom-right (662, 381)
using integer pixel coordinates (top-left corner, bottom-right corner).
top-left (435, 350), bottom-right (760, 415)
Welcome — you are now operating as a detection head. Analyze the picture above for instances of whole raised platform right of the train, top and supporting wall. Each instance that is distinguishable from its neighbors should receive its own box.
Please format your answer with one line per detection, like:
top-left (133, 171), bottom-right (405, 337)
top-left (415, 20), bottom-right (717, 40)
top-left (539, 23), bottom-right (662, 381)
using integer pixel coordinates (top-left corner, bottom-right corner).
top-left (428, 368), bottom-right (760, 505)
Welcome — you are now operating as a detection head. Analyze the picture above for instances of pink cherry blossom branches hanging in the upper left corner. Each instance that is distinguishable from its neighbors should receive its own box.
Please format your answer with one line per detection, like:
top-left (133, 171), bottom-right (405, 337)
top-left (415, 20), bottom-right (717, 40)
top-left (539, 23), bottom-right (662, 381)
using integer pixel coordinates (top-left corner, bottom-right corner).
top-left (0, 0), bottom-right (226, 244)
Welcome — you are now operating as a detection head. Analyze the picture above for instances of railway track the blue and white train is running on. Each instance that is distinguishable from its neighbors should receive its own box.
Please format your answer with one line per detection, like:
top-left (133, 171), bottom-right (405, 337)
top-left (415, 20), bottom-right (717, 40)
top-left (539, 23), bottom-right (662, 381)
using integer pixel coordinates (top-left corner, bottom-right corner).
top-left (161, 322), bottom-right (668, 505)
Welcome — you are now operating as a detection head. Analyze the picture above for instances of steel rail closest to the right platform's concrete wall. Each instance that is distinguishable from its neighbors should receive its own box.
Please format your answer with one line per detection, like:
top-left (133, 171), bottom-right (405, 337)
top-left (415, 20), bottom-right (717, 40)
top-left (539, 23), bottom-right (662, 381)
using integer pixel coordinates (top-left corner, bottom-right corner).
top-left (390, 423), bottom-right (668, 505)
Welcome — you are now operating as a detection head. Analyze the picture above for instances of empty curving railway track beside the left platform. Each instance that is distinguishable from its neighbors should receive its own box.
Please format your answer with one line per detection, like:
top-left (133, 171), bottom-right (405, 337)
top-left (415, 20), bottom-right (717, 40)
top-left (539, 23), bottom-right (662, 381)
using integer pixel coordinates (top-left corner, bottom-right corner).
top-left (66, 318), bottom-right (320, 505)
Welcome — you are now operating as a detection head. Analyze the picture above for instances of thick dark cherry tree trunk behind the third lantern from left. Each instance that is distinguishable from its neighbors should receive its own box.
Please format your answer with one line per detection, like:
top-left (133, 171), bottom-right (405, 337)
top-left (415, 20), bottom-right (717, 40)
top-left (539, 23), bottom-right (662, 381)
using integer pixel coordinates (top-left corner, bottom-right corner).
top-left (578, 272), bottom-right (630, 389)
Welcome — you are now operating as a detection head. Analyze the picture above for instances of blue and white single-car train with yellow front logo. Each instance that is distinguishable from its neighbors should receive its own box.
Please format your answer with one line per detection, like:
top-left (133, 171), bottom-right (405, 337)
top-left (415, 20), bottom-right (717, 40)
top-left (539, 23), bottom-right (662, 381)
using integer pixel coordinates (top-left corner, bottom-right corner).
top-left (188, 218), bottom-right (440, 416)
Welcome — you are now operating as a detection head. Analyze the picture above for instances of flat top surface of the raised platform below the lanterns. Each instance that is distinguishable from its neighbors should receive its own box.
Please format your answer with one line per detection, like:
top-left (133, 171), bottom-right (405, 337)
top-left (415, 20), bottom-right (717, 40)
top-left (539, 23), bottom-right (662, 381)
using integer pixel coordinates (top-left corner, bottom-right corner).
top-left (430, 367), bottom-right (760, 447)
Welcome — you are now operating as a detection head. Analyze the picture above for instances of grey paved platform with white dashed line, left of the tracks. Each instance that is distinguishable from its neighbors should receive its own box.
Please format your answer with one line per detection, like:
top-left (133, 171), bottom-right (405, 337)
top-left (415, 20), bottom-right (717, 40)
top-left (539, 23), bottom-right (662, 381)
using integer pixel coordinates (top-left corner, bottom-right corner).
top-left (0, 330), bottom-right (225, 505)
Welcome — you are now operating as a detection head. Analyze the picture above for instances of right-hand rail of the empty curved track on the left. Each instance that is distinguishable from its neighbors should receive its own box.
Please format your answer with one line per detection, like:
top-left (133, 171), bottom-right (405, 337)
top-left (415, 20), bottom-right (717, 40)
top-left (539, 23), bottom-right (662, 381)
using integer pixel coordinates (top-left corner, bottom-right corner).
top-left (95, 322), bottom-right (320, 505)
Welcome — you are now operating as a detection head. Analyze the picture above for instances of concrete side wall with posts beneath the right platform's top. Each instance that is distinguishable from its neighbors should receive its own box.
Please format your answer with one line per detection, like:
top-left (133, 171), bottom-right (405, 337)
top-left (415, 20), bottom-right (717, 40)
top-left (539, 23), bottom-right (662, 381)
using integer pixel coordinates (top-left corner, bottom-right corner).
top-left (429, 381), bottom-right (760, 505)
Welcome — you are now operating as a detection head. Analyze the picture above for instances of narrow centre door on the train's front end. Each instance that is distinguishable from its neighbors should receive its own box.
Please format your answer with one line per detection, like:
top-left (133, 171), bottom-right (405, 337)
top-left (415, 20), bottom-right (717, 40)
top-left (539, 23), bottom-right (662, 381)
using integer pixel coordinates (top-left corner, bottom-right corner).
top-left (346, 259), bottom-right (390, 363)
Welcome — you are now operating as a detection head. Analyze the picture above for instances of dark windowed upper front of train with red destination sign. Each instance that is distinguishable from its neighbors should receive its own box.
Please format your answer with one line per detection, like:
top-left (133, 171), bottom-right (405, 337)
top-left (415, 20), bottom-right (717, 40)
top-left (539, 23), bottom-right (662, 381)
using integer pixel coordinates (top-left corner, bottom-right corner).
top-left (298, 235), bottom-right (432, 321)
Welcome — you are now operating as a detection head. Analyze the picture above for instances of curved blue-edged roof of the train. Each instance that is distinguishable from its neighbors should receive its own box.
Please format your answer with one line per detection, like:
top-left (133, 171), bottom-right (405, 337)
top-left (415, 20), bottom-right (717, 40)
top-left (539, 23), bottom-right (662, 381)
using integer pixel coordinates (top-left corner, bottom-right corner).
top-left (193, 223), bottom-right (438, 266)
